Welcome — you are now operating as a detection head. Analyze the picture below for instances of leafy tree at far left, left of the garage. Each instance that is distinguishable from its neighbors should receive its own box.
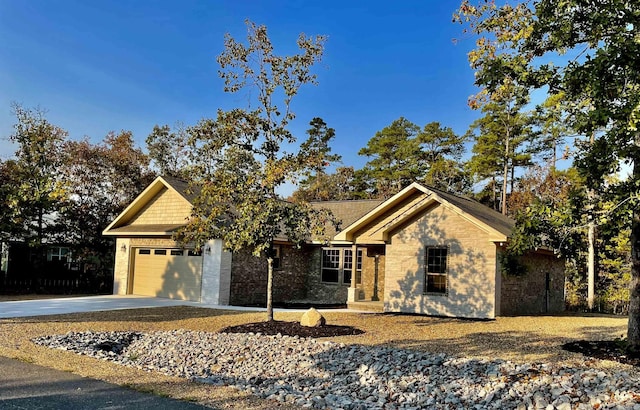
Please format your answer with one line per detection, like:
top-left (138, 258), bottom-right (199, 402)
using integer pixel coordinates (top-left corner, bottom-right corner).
top-left (6, 104), bottom-right (67, 256)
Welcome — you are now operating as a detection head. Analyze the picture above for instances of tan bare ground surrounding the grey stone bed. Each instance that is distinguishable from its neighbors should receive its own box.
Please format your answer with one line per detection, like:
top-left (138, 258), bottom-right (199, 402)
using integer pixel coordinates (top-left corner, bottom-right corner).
top-left (0, 307), bottom-right (637, 409)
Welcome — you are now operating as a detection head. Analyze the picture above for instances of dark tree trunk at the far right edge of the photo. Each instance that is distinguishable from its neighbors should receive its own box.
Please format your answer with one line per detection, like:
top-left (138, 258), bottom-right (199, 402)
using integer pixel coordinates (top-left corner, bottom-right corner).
top-left (627, 160), bottom-right (640, 355)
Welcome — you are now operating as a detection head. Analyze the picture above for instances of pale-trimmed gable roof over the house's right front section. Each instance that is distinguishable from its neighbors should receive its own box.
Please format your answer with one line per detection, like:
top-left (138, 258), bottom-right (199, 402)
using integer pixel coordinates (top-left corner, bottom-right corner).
top-left (334, 182), bottom-right (515, 242)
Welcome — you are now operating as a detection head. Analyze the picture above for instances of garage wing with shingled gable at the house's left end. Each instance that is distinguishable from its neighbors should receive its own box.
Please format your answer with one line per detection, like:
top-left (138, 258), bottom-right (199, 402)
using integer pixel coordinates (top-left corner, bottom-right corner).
top-left (103, 177), bottom-right (232, 304)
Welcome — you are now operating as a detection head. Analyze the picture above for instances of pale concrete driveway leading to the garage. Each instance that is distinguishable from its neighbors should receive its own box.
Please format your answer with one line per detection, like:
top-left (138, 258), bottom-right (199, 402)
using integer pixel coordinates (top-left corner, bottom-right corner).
top-left (0, 295), bottom-right (204, 319)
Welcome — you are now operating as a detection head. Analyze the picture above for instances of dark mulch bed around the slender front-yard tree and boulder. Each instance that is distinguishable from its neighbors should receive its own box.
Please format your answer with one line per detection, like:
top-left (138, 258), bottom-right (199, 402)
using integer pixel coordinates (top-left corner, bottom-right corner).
top-left (220, 320), bottom-right (364, 338)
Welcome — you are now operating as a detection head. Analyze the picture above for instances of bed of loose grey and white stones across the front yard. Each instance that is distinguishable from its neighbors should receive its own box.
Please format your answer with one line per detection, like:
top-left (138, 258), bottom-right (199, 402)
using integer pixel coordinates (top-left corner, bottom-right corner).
top-left (34, 330), bottom-right (640, 410)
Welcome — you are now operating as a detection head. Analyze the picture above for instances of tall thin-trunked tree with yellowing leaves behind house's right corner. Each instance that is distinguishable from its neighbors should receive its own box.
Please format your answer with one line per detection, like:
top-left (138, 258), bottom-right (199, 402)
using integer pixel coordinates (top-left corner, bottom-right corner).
top-left (454, 0), bottom-right (533, 215)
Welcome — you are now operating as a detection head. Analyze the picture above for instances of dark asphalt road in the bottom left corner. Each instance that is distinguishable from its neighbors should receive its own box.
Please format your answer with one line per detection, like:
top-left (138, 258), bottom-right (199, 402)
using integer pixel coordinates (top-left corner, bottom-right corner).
top-left (0, 356), bottom-right (208, 410)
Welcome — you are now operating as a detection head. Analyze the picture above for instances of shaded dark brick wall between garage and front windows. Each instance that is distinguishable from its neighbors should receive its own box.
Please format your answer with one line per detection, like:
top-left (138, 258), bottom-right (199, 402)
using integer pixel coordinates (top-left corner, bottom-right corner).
top-left (229, 246), bottom-right (310, 306)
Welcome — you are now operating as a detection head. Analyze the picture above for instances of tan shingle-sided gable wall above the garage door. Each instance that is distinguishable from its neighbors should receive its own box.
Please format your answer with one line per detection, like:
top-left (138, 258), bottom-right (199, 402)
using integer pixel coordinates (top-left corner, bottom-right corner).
top-left (129, 188), bottom-right (191, 225)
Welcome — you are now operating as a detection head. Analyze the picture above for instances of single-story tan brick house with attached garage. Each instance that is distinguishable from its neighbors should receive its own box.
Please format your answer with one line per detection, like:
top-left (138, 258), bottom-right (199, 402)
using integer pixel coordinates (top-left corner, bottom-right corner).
top-left (104, 177), bottom-right (564, 319)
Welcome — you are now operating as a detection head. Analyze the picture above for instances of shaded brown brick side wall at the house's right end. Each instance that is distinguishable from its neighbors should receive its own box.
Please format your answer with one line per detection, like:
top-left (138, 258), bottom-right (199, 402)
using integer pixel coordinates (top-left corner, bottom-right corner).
top-left (500, 252), bottom-right (565, 316)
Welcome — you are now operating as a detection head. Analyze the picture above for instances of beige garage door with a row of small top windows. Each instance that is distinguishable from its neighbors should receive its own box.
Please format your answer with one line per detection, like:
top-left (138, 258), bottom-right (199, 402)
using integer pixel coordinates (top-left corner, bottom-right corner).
top-left (132, 248), bottom-right (202, 301)
